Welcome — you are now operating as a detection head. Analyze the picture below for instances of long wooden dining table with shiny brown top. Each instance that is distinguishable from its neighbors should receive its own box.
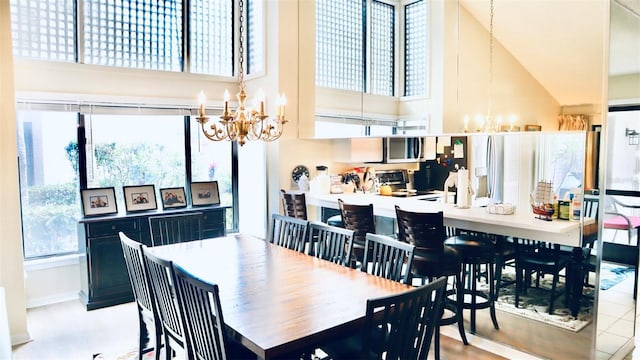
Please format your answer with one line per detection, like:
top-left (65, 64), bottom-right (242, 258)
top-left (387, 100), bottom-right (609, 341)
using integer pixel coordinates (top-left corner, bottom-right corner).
top-left (149, 235), bottom-right (411, 359)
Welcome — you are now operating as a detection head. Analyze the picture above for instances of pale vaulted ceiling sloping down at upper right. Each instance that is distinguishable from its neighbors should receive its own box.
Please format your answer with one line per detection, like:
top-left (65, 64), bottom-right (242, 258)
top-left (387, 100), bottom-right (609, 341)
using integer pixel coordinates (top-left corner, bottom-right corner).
top-left (460, 0), bottom-right (640, 105)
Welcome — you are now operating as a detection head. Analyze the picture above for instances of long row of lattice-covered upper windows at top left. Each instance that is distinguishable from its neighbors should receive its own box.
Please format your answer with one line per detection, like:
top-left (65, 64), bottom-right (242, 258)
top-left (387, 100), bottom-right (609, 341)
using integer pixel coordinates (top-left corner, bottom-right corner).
top-left (11, 0), bottom-right (264, 76)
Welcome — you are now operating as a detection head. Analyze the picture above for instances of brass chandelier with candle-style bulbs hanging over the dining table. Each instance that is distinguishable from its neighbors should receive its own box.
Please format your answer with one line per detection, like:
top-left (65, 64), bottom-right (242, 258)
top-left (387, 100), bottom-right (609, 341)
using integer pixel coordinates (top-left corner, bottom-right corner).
top-left (196, 0), bottom-right (287, 146)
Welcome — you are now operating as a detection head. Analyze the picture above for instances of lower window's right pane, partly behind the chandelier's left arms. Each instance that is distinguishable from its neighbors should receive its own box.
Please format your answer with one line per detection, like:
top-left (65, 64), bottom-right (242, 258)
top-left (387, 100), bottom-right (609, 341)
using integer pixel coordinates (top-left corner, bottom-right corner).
top-left (191, 117), bottom-right (235, 231)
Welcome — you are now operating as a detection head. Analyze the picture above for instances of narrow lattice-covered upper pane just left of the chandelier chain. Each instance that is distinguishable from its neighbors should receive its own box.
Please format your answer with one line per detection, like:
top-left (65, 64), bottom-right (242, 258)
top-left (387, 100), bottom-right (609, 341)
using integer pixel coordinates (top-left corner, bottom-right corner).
top-left (189, 0), bottom-right (233, 76)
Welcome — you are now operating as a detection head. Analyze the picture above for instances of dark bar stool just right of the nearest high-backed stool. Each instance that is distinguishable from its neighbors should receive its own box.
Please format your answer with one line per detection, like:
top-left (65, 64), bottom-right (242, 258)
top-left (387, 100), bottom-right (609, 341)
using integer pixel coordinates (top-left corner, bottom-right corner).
top-left (444, 233), bottom-right (500, 334)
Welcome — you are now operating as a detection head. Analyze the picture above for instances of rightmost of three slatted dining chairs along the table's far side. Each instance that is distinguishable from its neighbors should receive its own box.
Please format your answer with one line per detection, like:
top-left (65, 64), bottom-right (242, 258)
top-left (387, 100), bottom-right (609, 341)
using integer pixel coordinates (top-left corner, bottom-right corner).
top-left (361, 233), bottom-right (415, 284)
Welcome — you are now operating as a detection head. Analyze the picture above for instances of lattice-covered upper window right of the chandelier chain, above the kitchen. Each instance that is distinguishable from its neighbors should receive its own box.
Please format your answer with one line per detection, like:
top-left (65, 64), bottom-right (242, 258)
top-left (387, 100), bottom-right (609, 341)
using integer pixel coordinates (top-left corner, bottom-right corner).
top-left (315, 0), bottom-right (429, 96)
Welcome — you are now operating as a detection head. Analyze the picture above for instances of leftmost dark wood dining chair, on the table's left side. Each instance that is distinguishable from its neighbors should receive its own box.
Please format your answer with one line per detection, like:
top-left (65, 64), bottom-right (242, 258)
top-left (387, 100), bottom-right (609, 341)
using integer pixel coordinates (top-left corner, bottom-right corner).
top-left (118, 232), bottom-right (162, 360)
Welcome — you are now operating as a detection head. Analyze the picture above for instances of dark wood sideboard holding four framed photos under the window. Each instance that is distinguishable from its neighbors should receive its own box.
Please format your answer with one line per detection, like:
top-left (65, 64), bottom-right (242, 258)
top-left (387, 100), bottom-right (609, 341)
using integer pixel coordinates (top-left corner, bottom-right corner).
top-left (78, 206), bottom-right (227, 310)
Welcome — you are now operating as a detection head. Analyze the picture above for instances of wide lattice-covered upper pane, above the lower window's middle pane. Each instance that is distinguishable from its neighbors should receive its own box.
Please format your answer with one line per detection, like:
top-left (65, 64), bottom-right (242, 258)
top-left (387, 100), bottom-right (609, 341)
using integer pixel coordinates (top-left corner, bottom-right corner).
top-left (83, 0), bottom-right (183, 71)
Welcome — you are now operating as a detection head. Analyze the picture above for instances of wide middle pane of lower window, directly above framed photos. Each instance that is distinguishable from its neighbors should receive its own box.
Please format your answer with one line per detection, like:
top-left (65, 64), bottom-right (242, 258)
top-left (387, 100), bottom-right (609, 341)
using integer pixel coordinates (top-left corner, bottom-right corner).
top-left (85, 115), bottom-right (186, 212)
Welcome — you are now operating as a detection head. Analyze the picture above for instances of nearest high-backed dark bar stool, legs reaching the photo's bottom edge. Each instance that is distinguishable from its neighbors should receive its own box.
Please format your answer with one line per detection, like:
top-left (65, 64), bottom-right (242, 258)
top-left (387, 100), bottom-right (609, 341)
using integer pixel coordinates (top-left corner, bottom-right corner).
top-left (395, 205), bottom-right (469, 359)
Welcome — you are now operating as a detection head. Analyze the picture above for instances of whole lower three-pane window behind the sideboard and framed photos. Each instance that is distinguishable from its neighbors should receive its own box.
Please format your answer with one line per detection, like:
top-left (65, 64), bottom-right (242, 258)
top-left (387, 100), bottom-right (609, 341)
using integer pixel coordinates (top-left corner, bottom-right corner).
top-left (17, 104), bottom-right (238, 259)
